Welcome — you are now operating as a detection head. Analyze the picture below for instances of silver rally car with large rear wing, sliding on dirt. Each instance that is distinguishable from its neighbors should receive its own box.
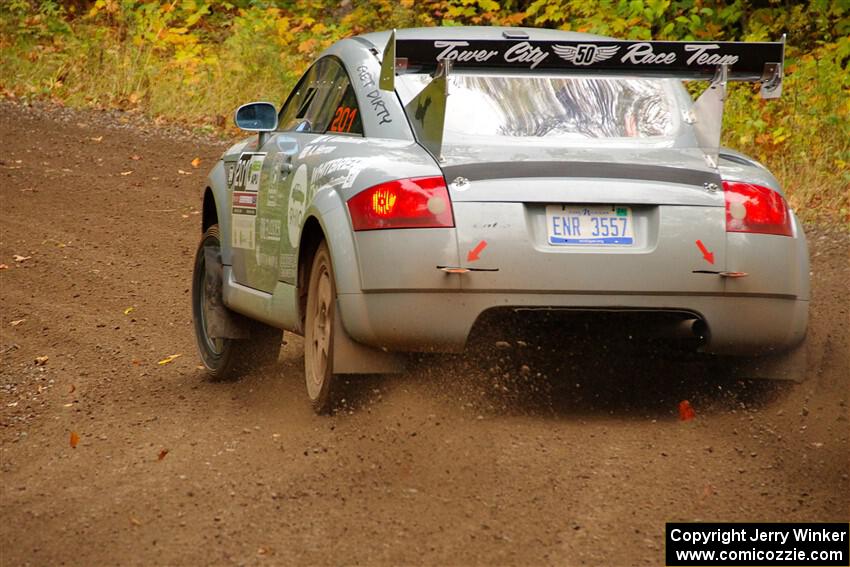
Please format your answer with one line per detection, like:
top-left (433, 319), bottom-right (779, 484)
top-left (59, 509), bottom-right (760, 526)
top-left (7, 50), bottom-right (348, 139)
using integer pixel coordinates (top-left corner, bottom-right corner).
top-left (192, 27), bottom-right (809, 412)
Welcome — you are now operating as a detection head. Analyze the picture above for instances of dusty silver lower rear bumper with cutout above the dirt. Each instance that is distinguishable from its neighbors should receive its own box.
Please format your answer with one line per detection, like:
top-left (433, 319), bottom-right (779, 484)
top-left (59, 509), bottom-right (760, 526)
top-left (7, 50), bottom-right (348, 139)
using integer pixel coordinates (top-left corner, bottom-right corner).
top-left (338, 291), bottom-right (809, 355)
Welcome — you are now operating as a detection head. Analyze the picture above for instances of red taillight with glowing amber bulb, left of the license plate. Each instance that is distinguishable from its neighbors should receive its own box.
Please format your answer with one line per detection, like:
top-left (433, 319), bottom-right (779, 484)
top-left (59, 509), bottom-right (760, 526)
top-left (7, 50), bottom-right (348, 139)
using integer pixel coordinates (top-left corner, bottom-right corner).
top-left (348, 176), bottom-right (455, 230)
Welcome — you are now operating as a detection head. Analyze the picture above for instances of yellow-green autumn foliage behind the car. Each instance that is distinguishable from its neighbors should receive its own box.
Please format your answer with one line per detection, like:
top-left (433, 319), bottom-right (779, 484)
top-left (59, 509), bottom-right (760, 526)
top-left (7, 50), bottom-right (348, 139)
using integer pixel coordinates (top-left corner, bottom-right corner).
top-left (0, 0), bottom-right (850, 223)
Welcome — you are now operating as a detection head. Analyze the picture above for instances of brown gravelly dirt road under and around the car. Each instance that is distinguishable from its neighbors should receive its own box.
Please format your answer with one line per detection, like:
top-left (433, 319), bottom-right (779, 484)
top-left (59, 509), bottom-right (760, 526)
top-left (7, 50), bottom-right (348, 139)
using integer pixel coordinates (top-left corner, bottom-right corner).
top-left (0, 102), bottom-right (850, 566)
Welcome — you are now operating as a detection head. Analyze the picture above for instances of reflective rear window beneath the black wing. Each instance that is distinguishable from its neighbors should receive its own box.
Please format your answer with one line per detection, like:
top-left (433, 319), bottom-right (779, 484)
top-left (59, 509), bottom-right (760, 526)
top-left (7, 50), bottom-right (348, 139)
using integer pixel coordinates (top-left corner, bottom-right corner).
top-left (397, 74), bottom-right (680, 143)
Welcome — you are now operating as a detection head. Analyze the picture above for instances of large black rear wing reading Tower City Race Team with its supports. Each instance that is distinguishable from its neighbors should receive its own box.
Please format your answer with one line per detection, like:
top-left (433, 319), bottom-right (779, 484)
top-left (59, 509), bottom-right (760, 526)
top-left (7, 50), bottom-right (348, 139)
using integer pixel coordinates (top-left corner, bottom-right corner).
top-left (380, 30), bottom-right (785, 167)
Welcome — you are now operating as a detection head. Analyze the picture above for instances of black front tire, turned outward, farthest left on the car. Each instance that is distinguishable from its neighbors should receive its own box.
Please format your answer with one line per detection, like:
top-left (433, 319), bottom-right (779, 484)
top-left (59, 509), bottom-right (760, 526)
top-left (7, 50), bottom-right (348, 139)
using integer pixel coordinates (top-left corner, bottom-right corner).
top-left (192, 224), bottom-right (283, 379)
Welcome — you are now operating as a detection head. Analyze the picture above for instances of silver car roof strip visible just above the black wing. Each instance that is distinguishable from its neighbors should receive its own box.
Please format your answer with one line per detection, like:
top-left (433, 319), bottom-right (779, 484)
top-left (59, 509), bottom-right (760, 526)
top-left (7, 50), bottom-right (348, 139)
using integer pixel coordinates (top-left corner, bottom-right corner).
top-left (357, 26), bottom-right (612, 49)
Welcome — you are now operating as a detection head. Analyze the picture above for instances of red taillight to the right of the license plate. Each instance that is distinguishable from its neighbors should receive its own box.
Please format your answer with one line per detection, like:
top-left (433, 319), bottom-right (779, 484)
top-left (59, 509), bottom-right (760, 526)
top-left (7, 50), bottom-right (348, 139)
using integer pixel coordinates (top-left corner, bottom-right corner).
top-left (723, 181), bottom-right (792, 236)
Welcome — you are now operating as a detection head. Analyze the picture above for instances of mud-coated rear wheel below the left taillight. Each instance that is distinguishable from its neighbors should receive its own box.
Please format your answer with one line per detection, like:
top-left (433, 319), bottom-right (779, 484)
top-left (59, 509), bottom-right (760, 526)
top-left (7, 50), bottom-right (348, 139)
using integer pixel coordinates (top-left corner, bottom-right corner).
top-left (304, 241), bottom-right (339, 414)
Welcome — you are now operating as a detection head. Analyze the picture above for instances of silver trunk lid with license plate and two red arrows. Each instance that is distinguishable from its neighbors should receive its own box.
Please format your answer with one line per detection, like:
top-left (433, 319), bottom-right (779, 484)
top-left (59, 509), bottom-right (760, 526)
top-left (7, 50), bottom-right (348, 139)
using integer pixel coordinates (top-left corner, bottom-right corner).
top-left (441, 148), bottom-right (726, 295)
